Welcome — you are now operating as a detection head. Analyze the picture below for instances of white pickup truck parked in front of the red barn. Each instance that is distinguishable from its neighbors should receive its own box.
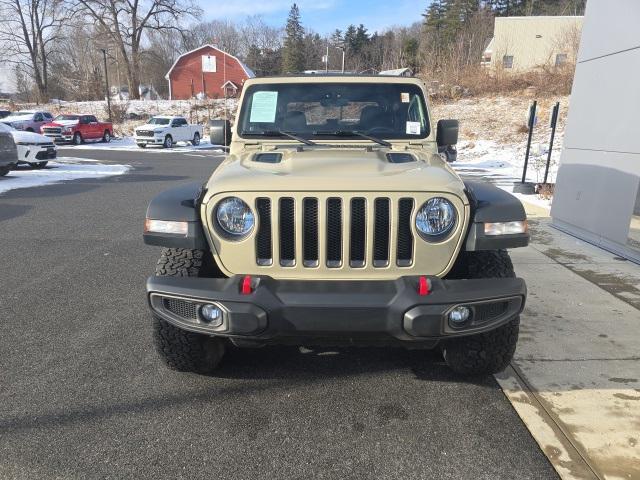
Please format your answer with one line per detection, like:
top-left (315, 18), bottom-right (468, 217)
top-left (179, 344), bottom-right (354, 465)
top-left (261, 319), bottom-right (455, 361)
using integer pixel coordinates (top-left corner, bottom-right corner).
top-left (135, 116), bottom-right (202, 148)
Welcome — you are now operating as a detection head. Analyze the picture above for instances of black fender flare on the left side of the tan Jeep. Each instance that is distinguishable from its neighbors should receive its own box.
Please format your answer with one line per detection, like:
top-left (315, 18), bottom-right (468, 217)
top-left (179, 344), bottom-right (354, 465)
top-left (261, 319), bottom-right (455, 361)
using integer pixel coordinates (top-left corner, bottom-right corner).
top-left (143, 183), bottom-right (209, 251)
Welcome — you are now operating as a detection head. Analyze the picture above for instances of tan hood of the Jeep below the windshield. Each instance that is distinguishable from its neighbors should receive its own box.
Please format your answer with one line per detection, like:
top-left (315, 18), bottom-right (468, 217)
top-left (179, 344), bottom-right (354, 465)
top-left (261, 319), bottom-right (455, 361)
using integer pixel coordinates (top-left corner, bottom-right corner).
top-left (208, 147), bottom-right (466, 202)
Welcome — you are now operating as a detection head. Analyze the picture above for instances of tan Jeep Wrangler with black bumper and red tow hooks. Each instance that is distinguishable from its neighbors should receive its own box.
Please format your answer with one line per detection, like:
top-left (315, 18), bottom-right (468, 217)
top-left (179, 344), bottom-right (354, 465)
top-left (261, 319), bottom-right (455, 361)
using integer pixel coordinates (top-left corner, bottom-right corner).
top-left (144, 75), bottom-right (529, 374)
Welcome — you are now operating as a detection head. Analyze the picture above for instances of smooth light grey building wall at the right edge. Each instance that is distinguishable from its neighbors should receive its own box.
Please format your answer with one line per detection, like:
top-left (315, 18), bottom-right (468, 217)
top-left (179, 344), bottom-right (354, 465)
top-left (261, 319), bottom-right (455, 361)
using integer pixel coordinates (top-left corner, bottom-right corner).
top-left (551, 0), bottom-right (640, 261)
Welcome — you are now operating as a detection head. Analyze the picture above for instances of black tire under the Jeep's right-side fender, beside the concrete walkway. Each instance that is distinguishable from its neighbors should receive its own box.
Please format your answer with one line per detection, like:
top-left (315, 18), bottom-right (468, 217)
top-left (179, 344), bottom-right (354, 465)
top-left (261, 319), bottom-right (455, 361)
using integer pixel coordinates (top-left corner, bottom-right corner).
top-left (443, 250), bottom-right (520, 375)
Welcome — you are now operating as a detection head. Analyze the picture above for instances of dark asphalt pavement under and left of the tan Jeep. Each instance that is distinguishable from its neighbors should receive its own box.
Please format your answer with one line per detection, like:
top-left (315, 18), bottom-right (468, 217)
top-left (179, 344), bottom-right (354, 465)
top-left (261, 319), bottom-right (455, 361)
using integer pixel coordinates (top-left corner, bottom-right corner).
top-left (0, 149), bottom-right (557, 479)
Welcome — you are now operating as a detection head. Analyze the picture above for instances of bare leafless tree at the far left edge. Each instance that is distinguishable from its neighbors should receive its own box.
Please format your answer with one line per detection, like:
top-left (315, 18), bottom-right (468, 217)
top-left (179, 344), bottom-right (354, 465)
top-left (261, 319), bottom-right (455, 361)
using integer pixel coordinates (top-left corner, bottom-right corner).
top-left (0, 0), bottom-right (65, 101)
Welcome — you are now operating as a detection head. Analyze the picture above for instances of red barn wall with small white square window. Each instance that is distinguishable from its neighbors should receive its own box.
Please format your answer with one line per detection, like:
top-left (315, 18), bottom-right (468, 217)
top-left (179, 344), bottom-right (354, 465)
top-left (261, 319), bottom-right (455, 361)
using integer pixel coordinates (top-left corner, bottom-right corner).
top-left (169, 47), bottom-right (249, 100)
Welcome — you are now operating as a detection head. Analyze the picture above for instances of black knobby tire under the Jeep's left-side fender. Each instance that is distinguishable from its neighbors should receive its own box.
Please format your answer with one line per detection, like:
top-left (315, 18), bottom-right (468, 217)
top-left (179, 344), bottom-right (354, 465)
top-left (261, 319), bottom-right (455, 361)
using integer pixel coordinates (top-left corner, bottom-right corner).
top-left (153, 248), bottom-right (225, 373)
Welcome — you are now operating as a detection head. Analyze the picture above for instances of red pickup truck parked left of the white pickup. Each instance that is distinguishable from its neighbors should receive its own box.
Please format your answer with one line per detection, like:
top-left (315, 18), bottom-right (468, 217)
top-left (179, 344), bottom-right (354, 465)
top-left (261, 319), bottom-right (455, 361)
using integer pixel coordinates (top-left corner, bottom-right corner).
top-left (40, 114), bottom-right (113, 145)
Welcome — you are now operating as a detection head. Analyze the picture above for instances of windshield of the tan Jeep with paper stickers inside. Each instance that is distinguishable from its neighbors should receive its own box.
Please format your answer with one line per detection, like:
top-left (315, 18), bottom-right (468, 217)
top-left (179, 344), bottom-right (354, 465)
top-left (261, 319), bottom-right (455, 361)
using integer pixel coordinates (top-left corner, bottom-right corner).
top-left (238, 82), bottom-right (429, 139)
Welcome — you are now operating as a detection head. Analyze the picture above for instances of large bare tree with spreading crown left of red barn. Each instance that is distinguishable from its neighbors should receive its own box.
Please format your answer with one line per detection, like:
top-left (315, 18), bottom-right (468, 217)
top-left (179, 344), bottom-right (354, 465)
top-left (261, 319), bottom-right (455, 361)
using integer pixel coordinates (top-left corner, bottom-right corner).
top-left (75, 0), bottom-right (200, 99)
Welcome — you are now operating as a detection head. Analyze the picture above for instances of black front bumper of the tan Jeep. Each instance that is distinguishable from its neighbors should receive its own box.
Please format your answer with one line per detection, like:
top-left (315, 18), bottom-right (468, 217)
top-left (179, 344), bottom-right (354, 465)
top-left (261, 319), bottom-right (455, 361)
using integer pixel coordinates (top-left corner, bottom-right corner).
top-left (147, 276), bottom-right (526, 346)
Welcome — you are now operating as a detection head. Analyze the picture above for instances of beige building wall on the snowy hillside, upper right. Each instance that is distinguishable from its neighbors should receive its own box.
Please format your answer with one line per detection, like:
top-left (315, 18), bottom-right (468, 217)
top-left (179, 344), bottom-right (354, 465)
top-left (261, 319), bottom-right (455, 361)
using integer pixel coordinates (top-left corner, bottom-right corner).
top-left (488, 17), bottom-right (583, 71)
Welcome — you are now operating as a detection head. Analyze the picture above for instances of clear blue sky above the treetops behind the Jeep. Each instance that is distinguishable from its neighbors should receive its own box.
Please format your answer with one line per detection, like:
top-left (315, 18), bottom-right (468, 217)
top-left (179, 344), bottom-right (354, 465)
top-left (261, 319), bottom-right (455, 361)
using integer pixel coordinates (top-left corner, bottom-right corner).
top-left (200, 0), bottom-right (430, 34)
